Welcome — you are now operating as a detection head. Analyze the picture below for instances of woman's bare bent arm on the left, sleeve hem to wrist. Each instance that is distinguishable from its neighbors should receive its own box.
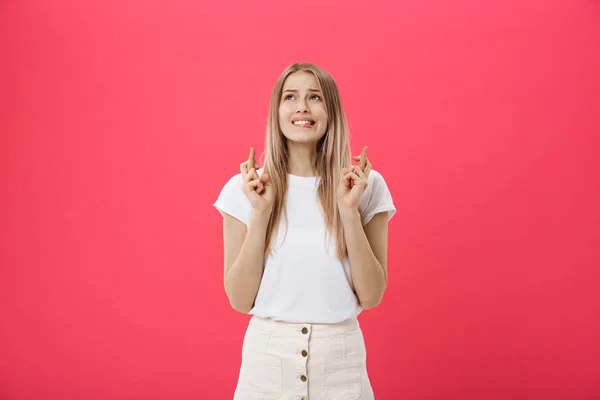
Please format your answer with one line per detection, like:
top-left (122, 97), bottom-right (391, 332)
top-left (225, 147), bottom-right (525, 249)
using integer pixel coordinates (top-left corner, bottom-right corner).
top-left (223, 212), bottom-right (270, 313)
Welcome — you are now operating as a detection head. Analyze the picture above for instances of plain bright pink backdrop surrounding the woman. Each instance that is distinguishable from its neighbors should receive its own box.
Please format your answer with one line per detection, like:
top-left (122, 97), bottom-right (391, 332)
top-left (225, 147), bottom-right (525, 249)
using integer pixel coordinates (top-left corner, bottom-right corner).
top-left (0, 0), bottom-right (600, 400)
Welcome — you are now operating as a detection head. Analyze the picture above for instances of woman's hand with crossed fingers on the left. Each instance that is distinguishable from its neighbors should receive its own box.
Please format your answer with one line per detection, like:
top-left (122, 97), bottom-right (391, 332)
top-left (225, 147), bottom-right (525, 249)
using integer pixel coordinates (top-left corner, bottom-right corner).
top-left (240, 147), bottom-right (274, 214)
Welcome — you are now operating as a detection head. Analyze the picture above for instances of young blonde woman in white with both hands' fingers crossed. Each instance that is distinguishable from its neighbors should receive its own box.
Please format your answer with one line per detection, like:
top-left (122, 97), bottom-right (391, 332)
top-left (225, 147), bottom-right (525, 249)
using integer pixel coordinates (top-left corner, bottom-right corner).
top-left (214, 64), bottom-right (396, 400)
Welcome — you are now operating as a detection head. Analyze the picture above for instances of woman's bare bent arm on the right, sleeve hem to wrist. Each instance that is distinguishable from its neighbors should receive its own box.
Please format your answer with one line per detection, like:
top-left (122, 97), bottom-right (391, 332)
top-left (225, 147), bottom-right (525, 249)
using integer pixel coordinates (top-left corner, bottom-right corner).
top-left (340, 211), bottom-right (388, 310)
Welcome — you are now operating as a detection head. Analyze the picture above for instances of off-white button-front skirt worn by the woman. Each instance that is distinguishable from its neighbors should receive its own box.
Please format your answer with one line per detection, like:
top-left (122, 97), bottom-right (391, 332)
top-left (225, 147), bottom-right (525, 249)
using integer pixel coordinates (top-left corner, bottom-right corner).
top-left (234, 316), bottom-right (374, 400)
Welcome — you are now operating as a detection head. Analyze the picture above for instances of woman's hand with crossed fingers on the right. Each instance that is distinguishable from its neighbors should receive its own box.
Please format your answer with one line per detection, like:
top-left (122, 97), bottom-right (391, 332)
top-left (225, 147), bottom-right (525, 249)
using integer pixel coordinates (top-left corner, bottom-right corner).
top-left (337, 146), bottom-right (371, 213)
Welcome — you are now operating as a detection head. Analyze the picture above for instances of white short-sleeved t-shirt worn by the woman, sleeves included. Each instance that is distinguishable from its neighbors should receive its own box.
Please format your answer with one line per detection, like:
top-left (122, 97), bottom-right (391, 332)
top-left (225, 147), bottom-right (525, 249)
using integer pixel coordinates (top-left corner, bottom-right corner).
top-left (214, 169), bottom-right (396, 323)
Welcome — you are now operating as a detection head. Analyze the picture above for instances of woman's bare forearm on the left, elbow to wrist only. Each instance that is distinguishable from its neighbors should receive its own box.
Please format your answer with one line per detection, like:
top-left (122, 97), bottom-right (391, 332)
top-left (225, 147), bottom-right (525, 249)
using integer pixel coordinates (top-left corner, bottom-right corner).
top-left (225, 213), bottom-right (270, 313)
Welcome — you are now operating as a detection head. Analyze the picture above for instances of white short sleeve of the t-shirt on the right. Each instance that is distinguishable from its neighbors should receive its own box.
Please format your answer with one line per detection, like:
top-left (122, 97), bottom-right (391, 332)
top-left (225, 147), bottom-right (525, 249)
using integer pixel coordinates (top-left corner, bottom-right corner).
top-left (359, 170), bottom-right (396, 226)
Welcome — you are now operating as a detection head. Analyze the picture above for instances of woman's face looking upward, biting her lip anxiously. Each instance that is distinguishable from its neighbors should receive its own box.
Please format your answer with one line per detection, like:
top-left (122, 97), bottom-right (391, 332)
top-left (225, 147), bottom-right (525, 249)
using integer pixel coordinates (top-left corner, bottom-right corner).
top-left (279, 71), bottom-right (327, 143)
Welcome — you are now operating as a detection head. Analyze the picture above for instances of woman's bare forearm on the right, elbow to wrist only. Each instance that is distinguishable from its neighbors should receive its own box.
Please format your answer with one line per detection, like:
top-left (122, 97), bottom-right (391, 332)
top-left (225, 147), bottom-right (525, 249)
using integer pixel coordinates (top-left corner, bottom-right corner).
top-left (340, 211), bottom-right (387, 309)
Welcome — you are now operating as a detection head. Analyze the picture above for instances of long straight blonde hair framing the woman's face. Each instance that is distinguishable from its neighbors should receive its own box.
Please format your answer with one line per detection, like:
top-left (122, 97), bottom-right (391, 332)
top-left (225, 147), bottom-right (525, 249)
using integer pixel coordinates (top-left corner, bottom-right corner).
top-left (264, 63), bottom-right (351, 260)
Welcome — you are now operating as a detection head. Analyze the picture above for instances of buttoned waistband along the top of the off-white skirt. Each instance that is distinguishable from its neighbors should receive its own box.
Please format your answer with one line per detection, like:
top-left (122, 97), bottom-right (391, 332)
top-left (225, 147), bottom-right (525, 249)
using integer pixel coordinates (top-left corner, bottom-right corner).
top-left (249, 315), bottom-right (360, 337)
